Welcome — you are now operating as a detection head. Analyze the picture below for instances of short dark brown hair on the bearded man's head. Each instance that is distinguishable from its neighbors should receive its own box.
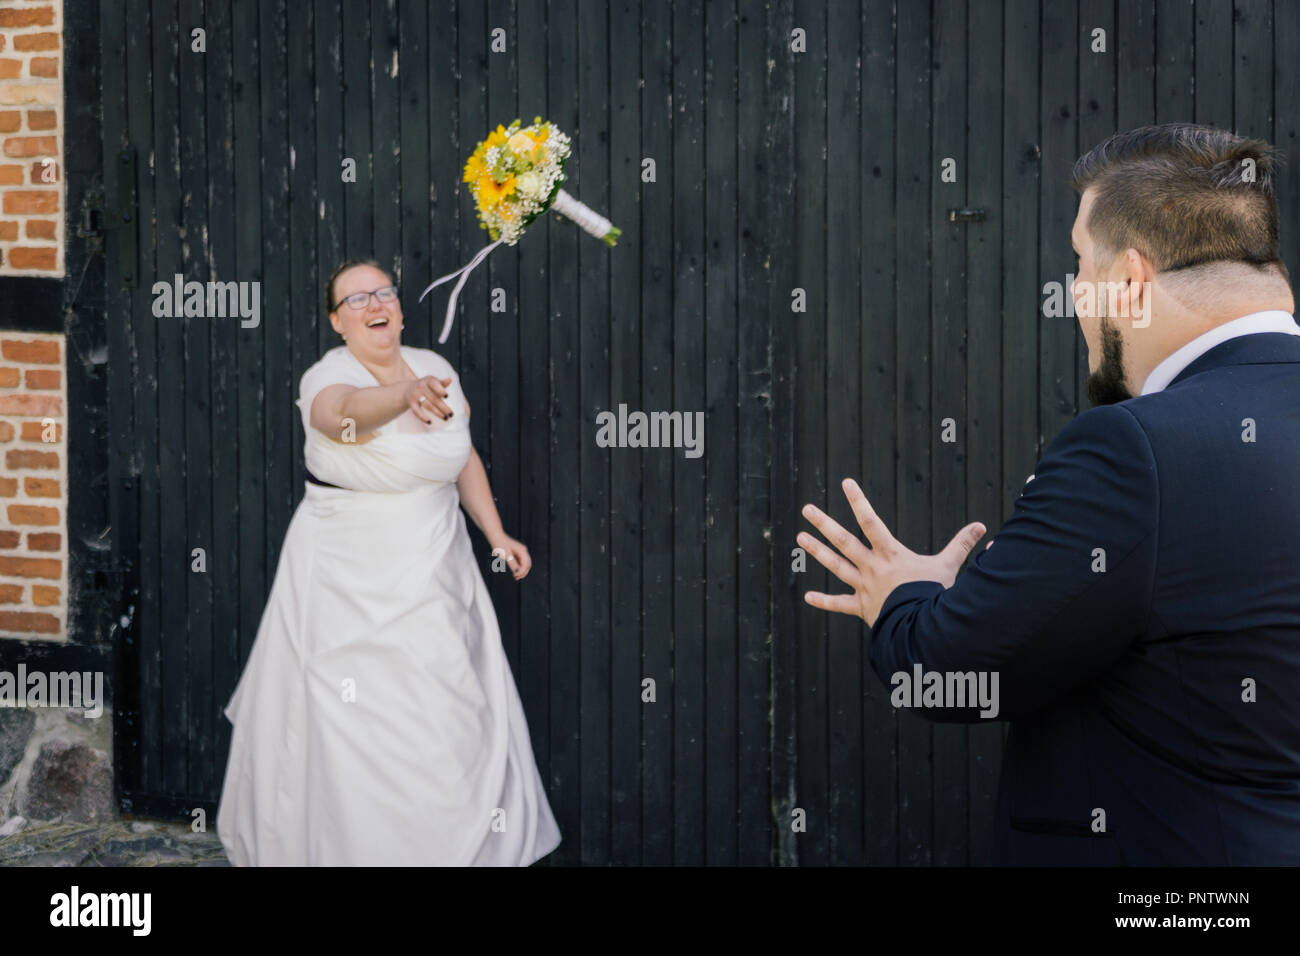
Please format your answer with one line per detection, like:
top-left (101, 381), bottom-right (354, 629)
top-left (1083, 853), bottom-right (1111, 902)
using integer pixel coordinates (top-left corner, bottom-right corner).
top-left (1074, 122), bottom-right (1290, 281)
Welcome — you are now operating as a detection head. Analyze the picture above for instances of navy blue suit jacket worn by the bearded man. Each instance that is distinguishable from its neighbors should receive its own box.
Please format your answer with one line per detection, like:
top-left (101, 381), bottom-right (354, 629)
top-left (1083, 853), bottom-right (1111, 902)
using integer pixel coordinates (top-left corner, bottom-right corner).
top-left (871, 333), bottom-right (1300, 865)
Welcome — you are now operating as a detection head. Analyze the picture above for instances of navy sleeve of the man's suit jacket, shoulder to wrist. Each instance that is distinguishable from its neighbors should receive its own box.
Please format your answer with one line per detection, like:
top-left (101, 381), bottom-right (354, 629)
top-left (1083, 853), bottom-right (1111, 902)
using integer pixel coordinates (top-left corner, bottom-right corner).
top-left (870, 405), bottom-right (1160, 722)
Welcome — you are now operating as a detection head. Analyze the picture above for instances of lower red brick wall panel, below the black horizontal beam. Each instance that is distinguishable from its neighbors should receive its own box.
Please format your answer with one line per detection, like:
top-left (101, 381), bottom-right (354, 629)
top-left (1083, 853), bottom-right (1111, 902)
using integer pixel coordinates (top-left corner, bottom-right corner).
top-left (0, 332), bottom-right (68, 640)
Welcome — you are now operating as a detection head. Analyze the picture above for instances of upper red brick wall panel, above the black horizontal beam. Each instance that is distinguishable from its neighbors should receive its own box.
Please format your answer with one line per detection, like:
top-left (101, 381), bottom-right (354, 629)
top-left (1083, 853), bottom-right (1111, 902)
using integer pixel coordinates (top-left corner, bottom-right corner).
top-left (0, 0), bottom-right (65, 277)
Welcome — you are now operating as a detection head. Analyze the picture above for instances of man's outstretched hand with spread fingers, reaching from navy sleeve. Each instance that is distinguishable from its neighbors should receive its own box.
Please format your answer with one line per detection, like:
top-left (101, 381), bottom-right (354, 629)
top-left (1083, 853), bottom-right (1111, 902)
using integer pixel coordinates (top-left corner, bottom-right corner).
top-left (798, 479), bottom-right (987, 627)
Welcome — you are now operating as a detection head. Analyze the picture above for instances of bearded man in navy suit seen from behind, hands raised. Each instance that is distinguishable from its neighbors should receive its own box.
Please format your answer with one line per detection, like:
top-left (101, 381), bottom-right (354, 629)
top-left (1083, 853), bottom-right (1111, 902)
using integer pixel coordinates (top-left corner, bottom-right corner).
top-left (800, 124), bottom-right (1300, 865)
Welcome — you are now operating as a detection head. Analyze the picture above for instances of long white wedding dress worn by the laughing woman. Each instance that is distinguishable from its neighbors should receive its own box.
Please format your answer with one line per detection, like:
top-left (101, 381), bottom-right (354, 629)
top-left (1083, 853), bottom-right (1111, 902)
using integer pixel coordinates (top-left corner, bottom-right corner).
top-left (217, 346), bottom-right (560, 866)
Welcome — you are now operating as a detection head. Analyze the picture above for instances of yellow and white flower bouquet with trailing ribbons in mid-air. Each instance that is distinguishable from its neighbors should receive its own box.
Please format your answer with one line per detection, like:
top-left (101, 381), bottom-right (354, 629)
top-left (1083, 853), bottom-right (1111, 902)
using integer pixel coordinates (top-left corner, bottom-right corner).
top-left (420, 116), bottom-right (620, 343)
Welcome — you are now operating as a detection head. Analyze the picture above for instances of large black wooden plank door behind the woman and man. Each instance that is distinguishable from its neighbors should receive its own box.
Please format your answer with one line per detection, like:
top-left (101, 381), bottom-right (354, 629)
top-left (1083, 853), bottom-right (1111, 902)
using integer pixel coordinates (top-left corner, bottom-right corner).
top-left (99, 0), bottom-right (1300, 864)
